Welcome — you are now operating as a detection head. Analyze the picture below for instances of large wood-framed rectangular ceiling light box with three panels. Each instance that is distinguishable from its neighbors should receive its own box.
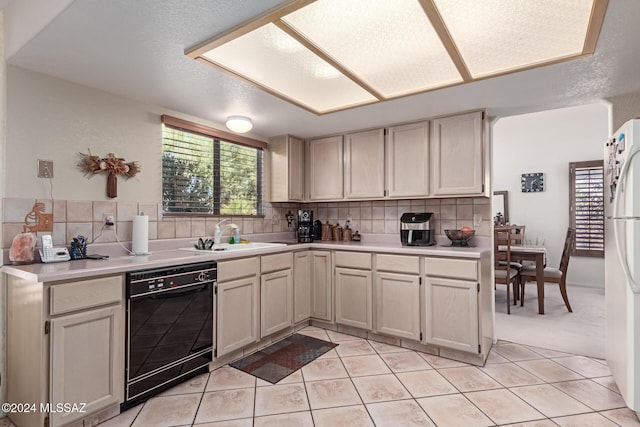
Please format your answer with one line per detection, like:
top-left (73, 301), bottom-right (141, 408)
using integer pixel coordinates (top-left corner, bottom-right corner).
top-left (185, 0), bottom-right (609, 115)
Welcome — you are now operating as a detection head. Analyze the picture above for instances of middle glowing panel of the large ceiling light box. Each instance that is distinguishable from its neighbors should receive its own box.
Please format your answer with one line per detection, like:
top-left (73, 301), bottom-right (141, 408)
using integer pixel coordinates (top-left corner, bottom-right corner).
top-left (282, 0), bottom-right (462, 98)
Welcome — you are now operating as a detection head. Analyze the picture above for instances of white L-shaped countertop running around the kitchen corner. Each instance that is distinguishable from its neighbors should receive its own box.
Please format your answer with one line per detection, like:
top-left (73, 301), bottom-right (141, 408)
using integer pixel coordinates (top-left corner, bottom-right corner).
top-left (2, 233), bottom-right (490, 282)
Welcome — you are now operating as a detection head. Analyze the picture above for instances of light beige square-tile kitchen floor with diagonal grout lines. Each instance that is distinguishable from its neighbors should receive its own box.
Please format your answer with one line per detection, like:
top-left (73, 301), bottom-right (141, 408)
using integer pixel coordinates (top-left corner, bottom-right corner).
top-left (6, 327), bottom-right (640, 427)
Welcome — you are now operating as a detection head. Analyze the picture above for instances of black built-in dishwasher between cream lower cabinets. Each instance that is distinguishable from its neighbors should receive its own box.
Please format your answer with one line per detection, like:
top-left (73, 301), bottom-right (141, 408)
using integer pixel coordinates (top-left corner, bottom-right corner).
top-left (121, 261), bottom-right (217, 409)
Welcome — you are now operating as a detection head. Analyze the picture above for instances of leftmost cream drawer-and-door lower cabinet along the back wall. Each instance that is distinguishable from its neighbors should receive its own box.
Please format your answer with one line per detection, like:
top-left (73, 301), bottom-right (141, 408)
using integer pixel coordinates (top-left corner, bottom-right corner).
top-left (333, 251), bottom-right (373, 331)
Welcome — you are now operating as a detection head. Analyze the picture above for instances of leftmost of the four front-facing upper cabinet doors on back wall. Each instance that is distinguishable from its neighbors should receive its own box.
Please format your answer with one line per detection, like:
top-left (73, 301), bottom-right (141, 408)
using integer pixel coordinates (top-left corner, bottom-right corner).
top-left (308, 136), bottom-right (344, 200)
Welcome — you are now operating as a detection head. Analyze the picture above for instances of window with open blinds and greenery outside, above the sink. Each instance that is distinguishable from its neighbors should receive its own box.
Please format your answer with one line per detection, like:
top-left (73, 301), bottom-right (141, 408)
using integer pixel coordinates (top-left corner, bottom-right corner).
top-left (162, 115), bottom-right (267, 216)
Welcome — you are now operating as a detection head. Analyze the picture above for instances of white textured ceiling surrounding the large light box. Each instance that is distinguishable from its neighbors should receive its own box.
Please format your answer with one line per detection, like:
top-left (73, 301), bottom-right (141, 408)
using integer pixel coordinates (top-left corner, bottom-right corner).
top-left (7, 0), bottom-right (640, 138)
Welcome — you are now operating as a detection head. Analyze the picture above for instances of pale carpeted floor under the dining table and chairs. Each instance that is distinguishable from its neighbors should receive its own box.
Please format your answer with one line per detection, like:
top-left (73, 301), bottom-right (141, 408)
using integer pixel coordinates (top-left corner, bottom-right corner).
top-left (495, 283), bottom-right (605, 359)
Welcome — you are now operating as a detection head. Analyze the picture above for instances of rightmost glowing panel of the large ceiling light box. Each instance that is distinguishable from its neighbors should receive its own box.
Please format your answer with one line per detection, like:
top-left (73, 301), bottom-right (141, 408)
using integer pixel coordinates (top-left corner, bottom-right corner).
top-left (434, 0), bottom-right (593, 78)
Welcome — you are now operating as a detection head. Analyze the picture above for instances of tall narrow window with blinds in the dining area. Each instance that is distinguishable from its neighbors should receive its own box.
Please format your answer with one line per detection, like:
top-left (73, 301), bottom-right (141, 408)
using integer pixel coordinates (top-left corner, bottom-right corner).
top-left (569, 160), bottom-right (604, 257)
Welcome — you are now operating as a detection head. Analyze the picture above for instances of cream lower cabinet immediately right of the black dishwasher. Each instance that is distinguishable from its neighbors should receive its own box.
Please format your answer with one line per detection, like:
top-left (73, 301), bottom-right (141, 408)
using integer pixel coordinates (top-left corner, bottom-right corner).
top-left (214, 257), bottom-right (260, 357)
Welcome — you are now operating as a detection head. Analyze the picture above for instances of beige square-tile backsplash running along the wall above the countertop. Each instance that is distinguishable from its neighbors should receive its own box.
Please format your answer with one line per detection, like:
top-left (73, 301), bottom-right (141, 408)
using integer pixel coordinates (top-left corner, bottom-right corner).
top-left (2, 197), bottom-right (492, 249)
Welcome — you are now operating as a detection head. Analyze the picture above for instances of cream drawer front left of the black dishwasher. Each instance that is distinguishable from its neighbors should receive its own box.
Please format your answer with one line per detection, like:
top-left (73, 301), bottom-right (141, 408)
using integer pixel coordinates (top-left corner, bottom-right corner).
top-left (50, 276), bottom-right (123, 316)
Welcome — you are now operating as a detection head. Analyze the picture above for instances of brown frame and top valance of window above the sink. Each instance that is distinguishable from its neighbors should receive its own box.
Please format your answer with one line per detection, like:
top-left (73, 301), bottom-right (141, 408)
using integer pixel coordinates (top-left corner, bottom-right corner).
top-left (160, 114), bottom-right (268, 218)
